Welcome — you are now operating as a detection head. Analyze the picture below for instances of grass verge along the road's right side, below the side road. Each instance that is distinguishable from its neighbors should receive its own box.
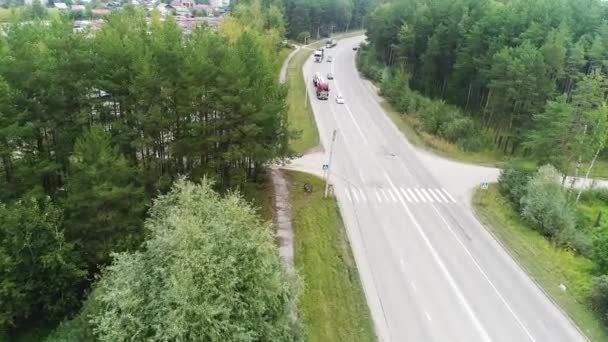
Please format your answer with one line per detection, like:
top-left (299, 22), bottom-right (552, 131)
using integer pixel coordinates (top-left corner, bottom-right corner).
top-left (473, 184), bottom-right (608, 341)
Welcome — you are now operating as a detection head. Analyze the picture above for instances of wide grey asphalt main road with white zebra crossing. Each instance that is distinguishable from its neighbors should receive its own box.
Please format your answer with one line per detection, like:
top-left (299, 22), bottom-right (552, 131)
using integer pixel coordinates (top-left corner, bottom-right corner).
top-left (303, 37), bottom-right (585, 342)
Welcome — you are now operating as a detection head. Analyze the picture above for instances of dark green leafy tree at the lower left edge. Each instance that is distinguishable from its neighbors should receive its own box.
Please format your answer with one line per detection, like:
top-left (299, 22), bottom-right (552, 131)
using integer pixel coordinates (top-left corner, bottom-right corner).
top-left (0, 197), bottom-right (86, 330)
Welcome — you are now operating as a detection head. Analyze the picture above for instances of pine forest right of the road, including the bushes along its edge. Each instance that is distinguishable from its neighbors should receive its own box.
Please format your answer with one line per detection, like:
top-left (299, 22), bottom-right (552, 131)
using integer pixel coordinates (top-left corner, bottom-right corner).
top-left (359, 0), bottom-right (608, 174)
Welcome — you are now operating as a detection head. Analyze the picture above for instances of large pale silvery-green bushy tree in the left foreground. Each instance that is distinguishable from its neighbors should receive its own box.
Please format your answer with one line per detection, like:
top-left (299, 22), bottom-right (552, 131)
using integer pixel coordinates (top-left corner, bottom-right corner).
top-left (90, 180), bottom-right (300, 342)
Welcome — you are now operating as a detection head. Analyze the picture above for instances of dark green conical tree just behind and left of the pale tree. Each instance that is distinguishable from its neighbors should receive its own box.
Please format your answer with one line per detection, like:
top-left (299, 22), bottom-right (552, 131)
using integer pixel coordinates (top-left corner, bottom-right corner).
top-left (63, 128), bottom-right (146, 267)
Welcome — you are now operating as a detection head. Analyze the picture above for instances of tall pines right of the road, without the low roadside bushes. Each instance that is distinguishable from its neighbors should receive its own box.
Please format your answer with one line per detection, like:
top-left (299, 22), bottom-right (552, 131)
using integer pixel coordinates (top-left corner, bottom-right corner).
top-left (367, 0), bottom-right (608, 162)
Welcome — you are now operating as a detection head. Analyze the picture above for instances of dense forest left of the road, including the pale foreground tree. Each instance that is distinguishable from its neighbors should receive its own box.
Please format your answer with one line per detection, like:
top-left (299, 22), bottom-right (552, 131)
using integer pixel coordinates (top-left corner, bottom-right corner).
top-left (0, 1), bottom-right (308, 341)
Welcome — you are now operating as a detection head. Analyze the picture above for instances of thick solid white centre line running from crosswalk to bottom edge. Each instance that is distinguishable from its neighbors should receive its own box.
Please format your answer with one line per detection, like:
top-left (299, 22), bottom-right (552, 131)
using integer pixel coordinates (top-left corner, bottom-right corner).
top-left (384, 172), bottom-right (491, 342)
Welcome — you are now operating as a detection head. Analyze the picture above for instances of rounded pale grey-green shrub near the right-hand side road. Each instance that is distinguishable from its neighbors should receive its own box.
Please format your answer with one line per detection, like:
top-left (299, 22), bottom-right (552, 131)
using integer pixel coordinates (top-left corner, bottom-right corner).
top-left (520, 165), bottom-right (575, 237)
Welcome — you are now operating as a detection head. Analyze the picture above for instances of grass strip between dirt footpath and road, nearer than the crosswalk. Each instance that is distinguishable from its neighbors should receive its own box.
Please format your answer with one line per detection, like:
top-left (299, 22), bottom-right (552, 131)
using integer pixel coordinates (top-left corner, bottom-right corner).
top-left (288, 172), bottom-right (376, 342)
